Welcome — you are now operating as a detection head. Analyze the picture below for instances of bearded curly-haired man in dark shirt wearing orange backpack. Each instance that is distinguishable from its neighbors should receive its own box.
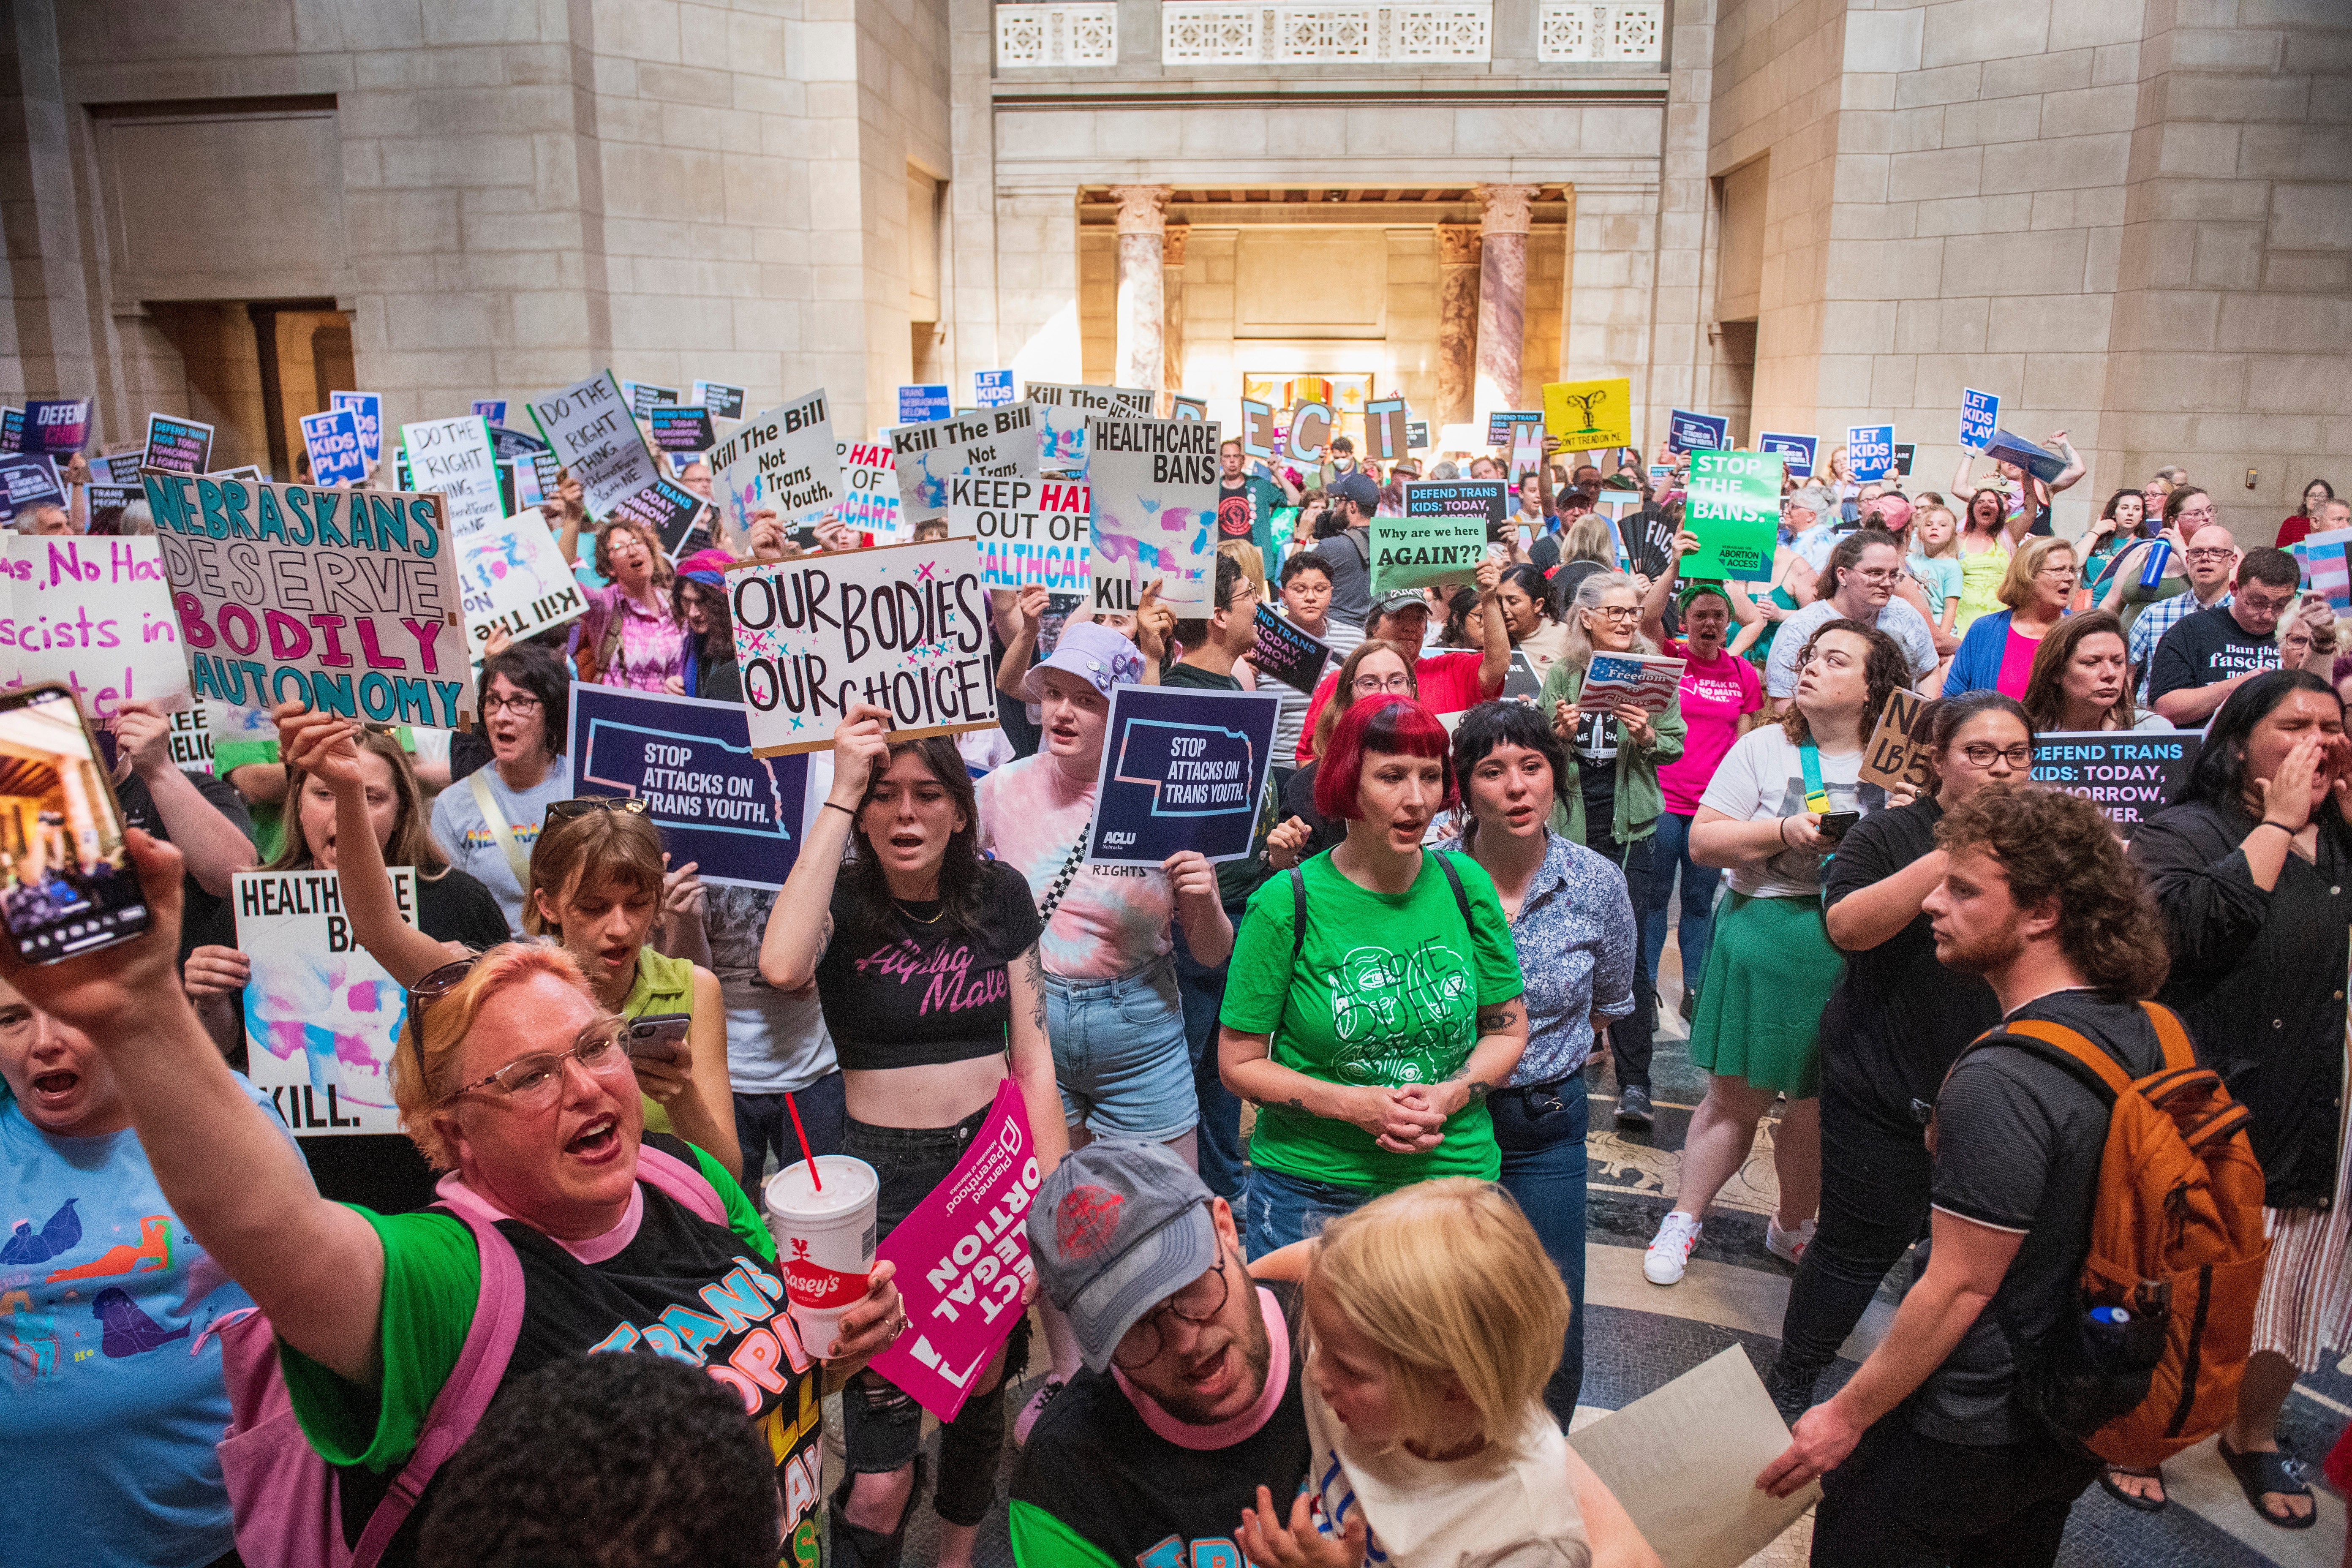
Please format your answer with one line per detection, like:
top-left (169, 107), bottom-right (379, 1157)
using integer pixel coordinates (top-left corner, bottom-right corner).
top-left (1757, 785), bottom-right (2268, 1568)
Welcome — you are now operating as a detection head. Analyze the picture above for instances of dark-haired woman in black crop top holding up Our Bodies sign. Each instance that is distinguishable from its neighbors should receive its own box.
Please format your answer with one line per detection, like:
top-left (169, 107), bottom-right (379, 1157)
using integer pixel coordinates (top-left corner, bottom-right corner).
top-left (760, 705), bottom-right (1068, 1565)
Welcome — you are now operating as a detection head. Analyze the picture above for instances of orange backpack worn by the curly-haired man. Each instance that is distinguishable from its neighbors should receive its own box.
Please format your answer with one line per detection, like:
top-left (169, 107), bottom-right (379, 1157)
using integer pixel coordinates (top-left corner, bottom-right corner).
top-left (1955, 1002), bottom-right (2270, 1469)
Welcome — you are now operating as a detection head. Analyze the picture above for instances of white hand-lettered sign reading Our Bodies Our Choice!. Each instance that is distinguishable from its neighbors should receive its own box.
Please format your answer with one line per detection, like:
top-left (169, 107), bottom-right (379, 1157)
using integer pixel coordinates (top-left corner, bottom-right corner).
top-left (727, 538), bottom-right (997, 757)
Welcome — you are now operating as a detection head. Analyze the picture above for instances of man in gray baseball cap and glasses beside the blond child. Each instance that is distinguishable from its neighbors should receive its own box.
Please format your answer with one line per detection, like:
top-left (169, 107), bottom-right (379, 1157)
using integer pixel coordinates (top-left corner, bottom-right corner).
top-left (1011, 1138), bottom-right (1308, 1568)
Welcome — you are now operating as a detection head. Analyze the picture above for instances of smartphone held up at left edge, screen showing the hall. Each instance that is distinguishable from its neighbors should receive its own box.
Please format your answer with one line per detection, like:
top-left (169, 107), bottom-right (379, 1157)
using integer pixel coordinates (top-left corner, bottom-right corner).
top-left (0, 684), bottom-right (148, 964)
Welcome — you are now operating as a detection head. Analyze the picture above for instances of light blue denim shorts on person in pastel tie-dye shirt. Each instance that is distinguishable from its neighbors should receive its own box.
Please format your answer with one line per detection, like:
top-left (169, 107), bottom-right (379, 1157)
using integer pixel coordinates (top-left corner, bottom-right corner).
top-left (1044, 959), bottom-right (1200, 1143)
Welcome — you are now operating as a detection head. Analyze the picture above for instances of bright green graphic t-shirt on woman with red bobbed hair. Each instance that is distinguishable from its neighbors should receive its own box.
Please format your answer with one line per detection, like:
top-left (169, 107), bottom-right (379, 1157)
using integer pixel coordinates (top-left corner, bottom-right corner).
top-left (1221, 853), bottom-right (1527, 1192)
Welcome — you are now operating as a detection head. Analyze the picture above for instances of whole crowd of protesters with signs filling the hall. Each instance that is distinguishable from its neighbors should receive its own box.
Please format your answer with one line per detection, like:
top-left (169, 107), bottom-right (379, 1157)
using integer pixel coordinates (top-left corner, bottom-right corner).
top-left (14, 374), bottom-right (2352, 1568)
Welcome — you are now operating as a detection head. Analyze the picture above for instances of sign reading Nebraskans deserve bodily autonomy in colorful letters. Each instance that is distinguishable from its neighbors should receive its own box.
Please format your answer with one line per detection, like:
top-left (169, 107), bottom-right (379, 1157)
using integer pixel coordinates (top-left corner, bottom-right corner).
top-left (146, 473), bottom-right (473, 729)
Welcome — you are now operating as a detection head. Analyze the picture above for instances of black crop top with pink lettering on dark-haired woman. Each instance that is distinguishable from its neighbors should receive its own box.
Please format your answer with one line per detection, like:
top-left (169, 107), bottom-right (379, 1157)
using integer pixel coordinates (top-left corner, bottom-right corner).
top-left (816, 860), bottom-right (1042, 1072)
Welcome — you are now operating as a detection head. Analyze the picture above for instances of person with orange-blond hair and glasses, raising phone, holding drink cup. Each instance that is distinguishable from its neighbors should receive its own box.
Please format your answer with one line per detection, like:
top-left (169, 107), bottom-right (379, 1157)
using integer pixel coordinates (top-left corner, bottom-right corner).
top-left (0, 841), bottom-right (906, 1568)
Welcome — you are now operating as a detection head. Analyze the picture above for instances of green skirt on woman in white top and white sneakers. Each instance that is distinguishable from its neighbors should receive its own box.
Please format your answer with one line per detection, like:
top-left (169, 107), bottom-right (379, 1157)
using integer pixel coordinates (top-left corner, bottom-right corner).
top-left (1691, 893), bottom-right (1846, 1100)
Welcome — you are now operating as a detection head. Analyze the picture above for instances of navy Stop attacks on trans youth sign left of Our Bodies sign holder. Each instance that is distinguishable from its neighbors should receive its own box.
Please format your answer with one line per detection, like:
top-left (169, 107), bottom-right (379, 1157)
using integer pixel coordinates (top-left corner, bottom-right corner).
top-left (564, 682), bottom-right (809, 889)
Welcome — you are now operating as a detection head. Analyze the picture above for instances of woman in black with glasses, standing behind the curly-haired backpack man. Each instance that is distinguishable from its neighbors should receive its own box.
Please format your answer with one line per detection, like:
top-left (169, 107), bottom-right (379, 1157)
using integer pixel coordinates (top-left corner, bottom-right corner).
top-left (1764, 691), bottom-right (2034, 1425)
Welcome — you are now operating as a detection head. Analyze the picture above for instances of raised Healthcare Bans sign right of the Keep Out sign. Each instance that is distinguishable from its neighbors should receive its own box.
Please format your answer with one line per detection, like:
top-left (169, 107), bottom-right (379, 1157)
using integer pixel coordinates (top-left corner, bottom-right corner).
top-left (1086, 414), bottom-right (1221, 616)
